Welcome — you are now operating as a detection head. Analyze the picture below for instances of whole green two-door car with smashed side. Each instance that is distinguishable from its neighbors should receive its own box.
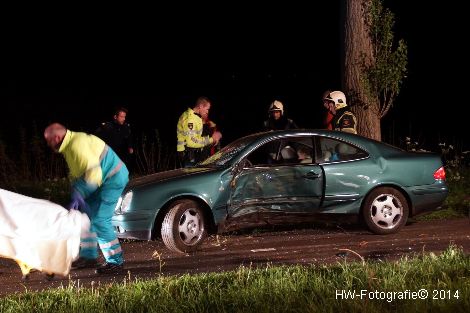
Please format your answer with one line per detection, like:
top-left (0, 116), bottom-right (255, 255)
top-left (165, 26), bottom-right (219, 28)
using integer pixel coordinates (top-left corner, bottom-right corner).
top-left (112, 129), bottom-right (448, 253)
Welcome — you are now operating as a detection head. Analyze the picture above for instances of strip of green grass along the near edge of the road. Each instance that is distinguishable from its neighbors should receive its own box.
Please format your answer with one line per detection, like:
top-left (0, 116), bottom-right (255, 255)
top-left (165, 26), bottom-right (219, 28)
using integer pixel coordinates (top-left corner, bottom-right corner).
top-left (0, 246), bottom-right (470, 313)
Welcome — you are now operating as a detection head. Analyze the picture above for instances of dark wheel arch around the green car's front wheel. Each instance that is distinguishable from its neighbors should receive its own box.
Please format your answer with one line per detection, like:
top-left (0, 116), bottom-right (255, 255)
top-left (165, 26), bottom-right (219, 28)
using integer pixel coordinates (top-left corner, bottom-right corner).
top-left (151, 195), bottom-right (217, 239)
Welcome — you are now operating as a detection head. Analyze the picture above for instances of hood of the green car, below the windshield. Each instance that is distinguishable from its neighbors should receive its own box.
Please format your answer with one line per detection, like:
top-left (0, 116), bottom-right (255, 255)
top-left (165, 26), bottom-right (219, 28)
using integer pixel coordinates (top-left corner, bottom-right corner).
top-left (126, 167), bottom-right (218, 189)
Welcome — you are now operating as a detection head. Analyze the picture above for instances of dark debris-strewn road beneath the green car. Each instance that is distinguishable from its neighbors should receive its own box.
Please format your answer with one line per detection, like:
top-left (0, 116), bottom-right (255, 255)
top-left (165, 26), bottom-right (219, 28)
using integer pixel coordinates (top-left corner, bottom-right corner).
top-left (0, 218), bottom-right (470, 296)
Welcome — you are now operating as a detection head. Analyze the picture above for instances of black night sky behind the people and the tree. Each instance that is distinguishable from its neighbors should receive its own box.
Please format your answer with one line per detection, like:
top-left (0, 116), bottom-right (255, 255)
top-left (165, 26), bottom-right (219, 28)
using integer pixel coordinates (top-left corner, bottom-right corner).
top-left (0, 0), bottom-right (470, 149)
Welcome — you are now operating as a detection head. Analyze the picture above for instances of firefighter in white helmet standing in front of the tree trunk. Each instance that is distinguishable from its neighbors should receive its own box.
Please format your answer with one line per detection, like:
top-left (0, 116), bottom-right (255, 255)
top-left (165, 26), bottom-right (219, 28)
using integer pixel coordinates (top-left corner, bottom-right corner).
top-left (323, 91), bottom-right (357, 134)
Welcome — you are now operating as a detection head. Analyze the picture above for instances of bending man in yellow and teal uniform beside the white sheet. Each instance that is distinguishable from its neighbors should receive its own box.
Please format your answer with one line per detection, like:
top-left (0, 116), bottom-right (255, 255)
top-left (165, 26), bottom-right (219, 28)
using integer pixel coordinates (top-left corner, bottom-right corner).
top-left (44, 123), bottom-right (129, 274)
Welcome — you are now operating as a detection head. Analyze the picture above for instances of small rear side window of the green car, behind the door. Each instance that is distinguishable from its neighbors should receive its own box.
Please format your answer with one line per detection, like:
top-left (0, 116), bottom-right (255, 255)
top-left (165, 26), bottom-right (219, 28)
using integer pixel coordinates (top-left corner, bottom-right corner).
top-left (316, 137), bottom-right (368, 163)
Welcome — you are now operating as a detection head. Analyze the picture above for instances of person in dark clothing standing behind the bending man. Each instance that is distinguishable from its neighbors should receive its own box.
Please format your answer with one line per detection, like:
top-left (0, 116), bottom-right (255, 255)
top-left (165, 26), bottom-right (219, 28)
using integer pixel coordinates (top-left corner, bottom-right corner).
top-left (95, 107), bottom-right (134, 170)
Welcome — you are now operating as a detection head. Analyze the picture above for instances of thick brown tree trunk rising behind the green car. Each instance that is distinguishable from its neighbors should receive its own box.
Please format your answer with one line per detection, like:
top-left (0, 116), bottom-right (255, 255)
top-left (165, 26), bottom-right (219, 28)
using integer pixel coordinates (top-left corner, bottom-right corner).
top-left (342, 0), bottom-right (381, 140)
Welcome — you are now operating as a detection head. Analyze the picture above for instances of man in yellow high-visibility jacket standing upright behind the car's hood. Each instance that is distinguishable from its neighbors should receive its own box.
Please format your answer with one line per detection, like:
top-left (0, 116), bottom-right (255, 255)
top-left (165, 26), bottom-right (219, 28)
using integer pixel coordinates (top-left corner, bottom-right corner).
top-left (176, 97), bottom-right (222, 167)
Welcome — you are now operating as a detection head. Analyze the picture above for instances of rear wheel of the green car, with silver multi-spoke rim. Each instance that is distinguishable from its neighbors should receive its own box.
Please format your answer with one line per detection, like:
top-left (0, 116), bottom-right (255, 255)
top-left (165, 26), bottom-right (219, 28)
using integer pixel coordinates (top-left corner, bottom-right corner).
top-left (362, 187), bottom-right (409, 235)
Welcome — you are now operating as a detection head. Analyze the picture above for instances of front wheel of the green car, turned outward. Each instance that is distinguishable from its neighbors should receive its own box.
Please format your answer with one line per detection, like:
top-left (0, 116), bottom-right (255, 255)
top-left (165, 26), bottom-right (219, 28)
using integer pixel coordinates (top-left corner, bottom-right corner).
top-left (161, 200), bottom-right (207, 253)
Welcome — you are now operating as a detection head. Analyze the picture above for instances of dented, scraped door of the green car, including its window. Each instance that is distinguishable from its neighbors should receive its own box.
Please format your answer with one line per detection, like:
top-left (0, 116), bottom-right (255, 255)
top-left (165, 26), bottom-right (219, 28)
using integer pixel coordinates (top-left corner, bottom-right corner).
top-left (228, 138), bottom-right (324, 217)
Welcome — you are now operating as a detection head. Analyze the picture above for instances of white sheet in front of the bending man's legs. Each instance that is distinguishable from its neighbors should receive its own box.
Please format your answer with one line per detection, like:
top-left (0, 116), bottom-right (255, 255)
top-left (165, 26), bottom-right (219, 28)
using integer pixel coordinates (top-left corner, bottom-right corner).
top-left (0, 189), bottom-right (90, 276)
